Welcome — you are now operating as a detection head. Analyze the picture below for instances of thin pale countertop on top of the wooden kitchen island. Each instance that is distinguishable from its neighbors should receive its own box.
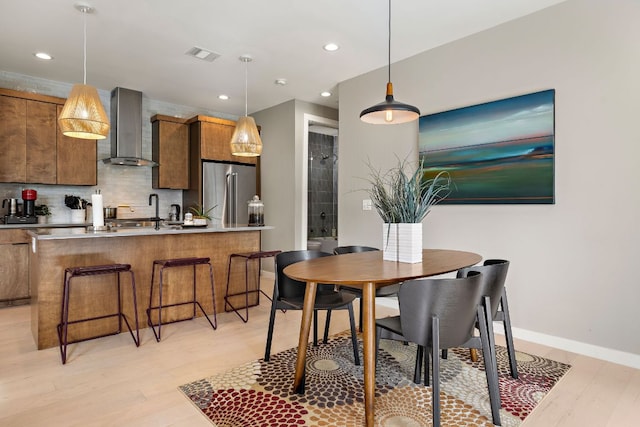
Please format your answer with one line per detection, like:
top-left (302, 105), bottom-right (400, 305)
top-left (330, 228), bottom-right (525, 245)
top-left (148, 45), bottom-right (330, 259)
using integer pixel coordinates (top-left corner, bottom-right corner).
top-left (27, 226), bottom-right (273, 240)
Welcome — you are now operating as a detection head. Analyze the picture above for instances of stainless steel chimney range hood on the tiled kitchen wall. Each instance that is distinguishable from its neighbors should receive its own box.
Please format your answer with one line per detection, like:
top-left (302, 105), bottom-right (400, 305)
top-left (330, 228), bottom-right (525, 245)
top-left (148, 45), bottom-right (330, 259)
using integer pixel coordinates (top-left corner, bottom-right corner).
top-left (102, 87), bottom-right (157, 166)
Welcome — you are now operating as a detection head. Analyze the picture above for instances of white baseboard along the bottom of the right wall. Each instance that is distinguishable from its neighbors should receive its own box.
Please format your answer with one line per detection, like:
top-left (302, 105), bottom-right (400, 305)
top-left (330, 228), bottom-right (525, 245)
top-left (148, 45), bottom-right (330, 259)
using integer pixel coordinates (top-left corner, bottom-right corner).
top-left (376, 298), bottom-right (640, 369)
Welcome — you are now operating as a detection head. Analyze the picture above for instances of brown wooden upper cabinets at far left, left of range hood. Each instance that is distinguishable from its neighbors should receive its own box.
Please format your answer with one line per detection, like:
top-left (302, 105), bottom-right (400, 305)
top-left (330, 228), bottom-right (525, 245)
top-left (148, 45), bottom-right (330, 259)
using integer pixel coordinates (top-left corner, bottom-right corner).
top-left (0, 89), bottom-right (97, 185)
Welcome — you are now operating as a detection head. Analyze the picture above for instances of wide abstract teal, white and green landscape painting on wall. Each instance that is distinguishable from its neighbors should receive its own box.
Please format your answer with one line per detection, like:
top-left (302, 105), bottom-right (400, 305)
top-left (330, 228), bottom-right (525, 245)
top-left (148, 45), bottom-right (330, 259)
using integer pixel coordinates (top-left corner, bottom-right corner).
top-left (419, 89), bottom-right (555, 204)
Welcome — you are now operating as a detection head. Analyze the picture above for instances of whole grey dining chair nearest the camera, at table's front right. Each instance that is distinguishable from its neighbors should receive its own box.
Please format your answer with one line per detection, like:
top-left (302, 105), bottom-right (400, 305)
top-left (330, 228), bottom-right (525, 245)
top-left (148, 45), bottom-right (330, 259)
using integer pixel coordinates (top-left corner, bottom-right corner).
top-left (376, 272), bottom-right (500, 426)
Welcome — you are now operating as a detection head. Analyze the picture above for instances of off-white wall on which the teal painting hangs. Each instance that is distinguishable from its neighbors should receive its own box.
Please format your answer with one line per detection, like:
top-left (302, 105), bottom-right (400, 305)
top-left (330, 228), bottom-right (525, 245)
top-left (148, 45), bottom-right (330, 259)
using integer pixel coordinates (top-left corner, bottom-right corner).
top-left (339, 0), bottom-right (640, 361)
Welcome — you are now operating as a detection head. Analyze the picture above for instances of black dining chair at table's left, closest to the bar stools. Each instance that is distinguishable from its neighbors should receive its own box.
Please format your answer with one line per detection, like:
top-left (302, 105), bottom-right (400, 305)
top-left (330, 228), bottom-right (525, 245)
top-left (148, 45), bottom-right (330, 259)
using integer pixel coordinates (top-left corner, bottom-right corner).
top-left (264, 250), bottom-right (360, 365)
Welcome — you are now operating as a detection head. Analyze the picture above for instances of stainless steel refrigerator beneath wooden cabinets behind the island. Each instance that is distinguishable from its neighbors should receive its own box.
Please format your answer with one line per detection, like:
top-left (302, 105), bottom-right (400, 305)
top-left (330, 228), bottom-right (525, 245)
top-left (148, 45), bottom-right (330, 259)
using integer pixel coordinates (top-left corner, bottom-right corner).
top-left (202, 161), bottom-right (256, 227)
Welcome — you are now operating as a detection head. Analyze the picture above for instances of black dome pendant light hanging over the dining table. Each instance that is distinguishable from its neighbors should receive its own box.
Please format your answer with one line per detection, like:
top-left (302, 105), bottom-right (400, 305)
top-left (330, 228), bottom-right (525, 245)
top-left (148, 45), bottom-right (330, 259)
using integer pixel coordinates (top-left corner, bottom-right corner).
top-left (360, 0), bottom-right (420, 125)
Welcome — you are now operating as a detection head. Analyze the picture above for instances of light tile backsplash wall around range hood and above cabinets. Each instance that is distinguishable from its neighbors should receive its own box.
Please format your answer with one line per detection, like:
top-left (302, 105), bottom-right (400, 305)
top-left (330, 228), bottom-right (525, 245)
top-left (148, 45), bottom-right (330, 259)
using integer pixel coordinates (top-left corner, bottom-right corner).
top-left (0, 71), bottom-right (237, 223)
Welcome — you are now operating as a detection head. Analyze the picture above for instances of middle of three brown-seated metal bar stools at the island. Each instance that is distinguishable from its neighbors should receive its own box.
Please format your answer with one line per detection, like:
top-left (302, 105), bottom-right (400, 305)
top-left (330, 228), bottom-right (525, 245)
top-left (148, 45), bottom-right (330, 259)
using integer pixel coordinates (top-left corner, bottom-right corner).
top-left (147, 257), bottom-right (218, 342)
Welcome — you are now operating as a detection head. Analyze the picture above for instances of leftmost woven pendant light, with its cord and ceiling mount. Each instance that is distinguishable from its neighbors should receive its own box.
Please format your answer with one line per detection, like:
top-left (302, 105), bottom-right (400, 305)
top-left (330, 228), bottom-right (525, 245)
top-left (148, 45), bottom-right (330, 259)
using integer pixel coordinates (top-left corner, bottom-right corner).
top-left (58, 4), bottom-right (109, 140)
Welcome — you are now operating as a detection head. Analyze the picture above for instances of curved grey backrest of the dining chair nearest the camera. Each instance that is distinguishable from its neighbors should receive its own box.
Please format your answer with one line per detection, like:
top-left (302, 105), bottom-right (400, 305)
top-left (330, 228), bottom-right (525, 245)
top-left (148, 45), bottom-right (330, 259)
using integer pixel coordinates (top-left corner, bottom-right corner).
top-left (398, 272), bottom-right (482, 348)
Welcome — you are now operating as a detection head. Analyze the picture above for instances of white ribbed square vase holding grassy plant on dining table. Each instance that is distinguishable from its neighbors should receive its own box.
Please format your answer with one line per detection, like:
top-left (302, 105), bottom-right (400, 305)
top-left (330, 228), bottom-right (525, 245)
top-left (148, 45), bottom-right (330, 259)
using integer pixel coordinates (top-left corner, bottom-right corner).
top-left (382, 223), bottom-right (422, 264)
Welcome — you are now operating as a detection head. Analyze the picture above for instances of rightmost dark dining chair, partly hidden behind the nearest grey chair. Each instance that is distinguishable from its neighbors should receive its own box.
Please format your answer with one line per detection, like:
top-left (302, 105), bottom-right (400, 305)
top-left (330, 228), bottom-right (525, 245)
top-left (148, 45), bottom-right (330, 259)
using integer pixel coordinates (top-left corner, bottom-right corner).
top-left (457, 259), bottom-right (518, 379)
